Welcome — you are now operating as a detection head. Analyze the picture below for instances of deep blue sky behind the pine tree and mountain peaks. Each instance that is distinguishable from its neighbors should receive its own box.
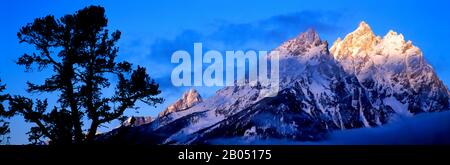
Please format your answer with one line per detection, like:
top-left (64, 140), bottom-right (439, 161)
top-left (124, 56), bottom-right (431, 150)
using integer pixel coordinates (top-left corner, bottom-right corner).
top-left (0, 0), bottom-right (450, 144)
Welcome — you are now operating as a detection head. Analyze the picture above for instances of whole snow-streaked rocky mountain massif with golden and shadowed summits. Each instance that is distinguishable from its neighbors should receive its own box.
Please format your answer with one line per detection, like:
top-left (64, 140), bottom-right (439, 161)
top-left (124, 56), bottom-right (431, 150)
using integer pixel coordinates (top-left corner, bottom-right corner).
top-left (98, 22), bottom-right (450, 144)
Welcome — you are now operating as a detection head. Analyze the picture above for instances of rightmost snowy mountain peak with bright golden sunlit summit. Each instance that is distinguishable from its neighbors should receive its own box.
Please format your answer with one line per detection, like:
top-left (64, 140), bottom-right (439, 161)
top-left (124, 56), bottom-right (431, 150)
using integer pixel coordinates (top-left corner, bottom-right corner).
top-left (330, 22), bottom-right (449, 115)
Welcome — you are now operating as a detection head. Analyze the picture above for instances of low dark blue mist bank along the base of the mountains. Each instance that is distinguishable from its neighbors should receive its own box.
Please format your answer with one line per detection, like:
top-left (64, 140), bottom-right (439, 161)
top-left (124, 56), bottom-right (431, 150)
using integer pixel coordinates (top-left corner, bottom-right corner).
top-left (212, 111), bottom-right (450, 145)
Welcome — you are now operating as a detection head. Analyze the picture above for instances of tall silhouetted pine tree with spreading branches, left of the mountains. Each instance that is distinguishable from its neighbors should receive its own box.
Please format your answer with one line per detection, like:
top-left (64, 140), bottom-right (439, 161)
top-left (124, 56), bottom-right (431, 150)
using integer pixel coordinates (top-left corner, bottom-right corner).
top-left (5, 6), bottom-right (163, 144)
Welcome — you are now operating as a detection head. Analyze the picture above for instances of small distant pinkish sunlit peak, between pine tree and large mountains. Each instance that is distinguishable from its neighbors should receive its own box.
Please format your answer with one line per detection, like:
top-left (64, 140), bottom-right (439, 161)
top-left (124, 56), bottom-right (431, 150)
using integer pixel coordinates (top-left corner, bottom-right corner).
top-left (159, 88), bottom-right (203, 117)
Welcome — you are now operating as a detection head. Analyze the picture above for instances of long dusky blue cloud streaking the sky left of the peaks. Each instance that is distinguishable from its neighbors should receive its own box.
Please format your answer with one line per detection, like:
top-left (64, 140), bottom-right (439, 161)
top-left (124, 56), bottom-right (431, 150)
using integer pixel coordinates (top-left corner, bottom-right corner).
top-left (133, 11), bottom-right (341, 86)
